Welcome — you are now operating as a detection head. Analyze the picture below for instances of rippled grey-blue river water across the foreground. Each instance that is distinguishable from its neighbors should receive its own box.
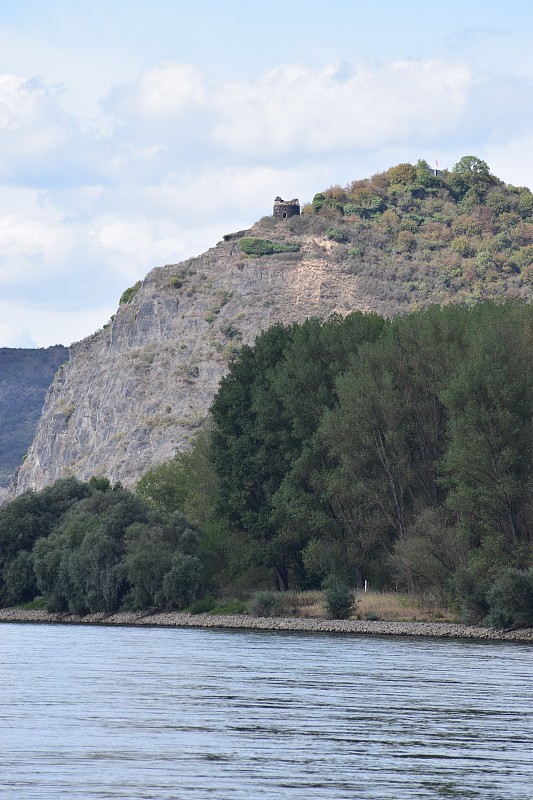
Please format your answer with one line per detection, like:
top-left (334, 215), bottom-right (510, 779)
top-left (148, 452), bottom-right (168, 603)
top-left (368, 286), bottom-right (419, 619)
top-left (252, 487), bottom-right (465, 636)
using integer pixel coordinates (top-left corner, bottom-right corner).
top-left (0, 624), bottom-right (533, 800)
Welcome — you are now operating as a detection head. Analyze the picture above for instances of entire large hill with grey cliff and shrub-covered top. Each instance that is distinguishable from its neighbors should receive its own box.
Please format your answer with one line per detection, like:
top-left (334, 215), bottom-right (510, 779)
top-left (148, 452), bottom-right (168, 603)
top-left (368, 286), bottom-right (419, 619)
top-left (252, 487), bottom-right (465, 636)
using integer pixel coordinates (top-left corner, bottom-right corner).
top-left (10, 156), bottom-right (533, 493)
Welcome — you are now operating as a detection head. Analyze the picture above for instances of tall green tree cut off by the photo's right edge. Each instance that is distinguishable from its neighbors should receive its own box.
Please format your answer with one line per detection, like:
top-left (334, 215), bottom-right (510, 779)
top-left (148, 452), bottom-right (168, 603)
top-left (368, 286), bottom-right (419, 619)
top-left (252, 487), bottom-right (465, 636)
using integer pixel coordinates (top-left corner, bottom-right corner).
top-left (441, 304), bottom-right (533, 575)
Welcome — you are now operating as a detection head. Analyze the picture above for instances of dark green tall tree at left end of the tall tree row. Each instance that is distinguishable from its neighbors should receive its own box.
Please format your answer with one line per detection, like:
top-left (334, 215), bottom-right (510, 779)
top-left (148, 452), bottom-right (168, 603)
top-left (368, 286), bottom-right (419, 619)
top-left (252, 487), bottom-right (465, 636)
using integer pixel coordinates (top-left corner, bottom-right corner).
top-left (207, 314), bottom-right (384, 589)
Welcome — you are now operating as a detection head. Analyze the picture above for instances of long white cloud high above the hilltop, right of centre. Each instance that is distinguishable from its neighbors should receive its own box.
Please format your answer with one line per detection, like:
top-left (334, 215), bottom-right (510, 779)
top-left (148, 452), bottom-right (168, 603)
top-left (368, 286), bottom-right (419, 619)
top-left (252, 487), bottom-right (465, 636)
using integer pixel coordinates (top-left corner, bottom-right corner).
top-left (211, 61), bottom-right (472, 156)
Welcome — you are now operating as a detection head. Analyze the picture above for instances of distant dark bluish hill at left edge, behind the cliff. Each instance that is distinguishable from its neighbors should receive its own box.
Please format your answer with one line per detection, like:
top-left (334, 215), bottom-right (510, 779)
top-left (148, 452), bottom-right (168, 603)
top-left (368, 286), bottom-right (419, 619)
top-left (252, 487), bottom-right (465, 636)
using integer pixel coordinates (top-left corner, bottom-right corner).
top-left (0, 345), bottom-right (68, 497)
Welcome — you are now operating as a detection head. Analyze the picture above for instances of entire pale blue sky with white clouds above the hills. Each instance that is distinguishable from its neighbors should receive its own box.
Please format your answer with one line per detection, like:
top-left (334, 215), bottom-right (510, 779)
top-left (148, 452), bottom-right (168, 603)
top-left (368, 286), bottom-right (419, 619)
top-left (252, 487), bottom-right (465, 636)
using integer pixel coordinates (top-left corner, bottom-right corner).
top-left (0, 0), bottom-right (533, 347)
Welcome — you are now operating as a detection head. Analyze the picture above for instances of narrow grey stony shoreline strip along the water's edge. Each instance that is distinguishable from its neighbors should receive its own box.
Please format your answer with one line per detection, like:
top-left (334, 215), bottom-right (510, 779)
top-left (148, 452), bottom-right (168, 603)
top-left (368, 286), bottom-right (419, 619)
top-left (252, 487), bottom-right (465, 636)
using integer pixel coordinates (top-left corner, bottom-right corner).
top-left (0, 608), bottom-right (533, 643)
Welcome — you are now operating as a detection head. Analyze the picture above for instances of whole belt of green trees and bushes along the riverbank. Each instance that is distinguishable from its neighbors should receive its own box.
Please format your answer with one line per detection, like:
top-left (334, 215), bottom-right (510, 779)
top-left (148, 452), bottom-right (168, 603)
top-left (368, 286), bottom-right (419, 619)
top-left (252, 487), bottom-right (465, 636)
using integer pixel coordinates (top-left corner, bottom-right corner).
top-left (0, 301), bottom-right (533, 627)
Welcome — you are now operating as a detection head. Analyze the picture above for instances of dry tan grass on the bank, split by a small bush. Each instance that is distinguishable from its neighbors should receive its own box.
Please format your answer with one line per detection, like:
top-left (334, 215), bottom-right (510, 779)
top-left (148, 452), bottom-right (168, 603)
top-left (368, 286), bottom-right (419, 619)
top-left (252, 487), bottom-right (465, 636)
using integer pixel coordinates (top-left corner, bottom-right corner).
top-left (285, 591), bottom-right (458, 622)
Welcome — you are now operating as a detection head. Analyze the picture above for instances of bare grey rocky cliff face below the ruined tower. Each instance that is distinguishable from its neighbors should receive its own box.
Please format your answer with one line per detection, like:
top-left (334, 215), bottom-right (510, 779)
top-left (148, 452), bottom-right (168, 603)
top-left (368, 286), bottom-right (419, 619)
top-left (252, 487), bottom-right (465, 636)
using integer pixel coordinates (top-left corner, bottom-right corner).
top-left (11, 221), bottom-right (376, 495)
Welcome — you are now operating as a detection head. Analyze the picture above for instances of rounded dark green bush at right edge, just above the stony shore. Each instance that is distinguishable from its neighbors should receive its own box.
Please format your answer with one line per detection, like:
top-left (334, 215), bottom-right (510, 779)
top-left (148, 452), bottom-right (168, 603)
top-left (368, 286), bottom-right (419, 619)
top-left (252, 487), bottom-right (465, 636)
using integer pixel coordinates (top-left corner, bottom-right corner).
top-left (485, 569), bottom-right (533, 630)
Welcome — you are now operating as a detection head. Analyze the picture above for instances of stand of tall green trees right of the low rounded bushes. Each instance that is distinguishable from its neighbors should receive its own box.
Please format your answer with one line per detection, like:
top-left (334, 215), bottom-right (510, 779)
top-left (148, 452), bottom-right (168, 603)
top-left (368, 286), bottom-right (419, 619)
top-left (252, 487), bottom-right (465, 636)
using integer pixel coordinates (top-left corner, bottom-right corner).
top-left (138, 302), bottom-right (533, 621)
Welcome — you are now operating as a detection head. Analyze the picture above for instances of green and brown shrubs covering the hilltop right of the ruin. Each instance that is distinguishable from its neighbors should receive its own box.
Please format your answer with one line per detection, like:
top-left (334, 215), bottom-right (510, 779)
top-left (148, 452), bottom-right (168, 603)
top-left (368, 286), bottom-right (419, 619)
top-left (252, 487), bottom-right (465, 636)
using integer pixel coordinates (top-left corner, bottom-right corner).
top-left (256, 156), bottom-right (533, 316)
